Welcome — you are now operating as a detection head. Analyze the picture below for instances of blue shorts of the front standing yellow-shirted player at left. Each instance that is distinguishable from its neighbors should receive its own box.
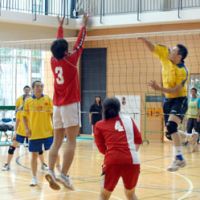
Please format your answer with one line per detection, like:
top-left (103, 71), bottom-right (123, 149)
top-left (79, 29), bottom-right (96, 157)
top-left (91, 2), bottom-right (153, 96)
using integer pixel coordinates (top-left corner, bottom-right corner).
top-left (29, 137), bottom-right (53, 152)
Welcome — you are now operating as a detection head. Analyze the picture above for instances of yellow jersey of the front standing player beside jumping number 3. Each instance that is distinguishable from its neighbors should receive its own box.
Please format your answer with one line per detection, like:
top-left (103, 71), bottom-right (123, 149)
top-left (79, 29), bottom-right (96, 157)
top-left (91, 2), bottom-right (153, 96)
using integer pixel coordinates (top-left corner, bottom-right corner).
top-left (23, 95), bottom-right (53, 140)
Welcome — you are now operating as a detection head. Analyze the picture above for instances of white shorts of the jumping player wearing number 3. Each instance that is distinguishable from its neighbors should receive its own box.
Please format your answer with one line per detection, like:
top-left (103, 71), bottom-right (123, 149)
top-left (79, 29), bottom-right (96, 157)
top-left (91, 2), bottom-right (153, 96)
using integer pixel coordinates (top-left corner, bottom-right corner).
top-left (53, 103), bottom-right (81, 129)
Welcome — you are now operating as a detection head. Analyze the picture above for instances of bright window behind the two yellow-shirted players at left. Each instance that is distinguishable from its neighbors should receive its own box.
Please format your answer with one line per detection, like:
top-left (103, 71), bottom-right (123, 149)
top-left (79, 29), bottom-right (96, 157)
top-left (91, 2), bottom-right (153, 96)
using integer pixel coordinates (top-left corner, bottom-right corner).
top-left (0, 48), bottom-right (44, 105)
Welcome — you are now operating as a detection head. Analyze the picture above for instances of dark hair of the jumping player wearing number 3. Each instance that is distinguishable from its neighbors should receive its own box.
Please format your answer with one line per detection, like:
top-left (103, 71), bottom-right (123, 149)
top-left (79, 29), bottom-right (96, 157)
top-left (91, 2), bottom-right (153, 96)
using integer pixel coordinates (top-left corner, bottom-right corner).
top-left (51, 39), bottom-right (68, 60)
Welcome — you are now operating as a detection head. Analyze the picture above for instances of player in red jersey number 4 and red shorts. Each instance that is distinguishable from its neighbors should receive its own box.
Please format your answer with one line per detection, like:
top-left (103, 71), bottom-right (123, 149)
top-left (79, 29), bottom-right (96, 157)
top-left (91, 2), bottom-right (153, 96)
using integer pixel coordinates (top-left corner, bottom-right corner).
top-left (94, 98), bottom-right (142, 200)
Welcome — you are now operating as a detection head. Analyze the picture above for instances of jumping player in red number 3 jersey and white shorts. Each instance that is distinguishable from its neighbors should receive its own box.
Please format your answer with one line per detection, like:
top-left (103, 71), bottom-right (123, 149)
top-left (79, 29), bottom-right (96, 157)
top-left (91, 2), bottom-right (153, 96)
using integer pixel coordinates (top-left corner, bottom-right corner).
top-left (45, 14), bottom-right (88, 190)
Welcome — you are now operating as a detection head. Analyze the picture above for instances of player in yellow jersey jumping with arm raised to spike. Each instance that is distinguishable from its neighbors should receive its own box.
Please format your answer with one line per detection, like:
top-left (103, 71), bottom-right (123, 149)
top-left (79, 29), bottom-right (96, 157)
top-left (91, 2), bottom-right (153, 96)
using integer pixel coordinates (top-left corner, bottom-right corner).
top-left (140, 38), bottom-right (188, 171)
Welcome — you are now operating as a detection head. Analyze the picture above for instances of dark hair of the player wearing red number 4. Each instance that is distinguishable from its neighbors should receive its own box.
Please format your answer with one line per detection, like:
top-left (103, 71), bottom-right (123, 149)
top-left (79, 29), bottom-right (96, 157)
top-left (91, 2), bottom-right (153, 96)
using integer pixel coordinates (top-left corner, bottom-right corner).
top-left (103, 97), bottom-right (120, 119)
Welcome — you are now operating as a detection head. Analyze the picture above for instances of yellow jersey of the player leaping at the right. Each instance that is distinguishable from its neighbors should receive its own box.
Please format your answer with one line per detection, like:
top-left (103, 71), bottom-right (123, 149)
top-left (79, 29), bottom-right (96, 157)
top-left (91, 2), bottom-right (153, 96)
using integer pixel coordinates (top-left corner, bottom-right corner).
top-left (154, 45), bottom-right (189, 98)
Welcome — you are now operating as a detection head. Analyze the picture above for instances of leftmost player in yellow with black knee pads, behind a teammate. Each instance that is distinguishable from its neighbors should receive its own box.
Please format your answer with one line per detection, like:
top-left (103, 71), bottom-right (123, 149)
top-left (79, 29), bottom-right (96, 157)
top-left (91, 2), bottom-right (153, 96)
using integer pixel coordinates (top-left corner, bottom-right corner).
top-left (2, 85), bottom-right (48, 171)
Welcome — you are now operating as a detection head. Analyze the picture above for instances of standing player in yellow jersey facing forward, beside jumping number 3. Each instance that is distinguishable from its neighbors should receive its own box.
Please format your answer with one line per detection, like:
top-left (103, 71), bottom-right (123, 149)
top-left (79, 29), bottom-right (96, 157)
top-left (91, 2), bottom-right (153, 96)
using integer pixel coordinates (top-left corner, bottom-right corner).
top-left (23, 81), bottom-right (53, 186)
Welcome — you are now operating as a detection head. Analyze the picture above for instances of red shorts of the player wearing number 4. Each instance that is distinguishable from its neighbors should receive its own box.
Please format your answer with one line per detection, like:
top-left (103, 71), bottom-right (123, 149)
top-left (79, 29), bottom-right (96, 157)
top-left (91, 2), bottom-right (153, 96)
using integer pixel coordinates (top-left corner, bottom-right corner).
top-left (104, 165), bottom-right (140, 192)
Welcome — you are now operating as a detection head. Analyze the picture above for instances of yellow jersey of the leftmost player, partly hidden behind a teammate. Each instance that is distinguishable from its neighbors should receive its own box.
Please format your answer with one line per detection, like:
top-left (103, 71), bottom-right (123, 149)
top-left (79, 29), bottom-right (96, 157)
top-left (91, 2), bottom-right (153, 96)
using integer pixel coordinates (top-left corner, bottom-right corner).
top-left (15, 96), bottom-right (26, 136)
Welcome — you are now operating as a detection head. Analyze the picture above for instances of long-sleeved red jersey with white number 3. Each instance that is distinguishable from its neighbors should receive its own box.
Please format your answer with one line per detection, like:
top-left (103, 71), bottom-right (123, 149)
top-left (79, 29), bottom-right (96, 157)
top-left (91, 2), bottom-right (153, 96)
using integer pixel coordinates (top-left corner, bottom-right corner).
top-left (51, 26), bottom-right (86, 106)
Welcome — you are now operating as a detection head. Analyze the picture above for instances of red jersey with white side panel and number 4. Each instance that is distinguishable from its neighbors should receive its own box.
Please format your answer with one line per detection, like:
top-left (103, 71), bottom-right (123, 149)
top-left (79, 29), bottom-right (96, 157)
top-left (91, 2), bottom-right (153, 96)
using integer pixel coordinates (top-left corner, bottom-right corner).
top-left (94, 116), bottom-right (142, 165)
